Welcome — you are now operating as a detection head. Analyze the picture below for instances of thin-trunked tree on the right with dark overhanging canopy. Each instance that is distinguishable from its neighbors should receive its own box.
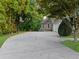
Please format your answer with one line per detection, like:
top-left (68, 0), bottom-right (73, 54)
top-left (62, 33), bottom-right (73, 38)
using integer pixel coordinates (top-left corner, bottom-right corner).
top-left (37, 0), bottom-right (79, 41)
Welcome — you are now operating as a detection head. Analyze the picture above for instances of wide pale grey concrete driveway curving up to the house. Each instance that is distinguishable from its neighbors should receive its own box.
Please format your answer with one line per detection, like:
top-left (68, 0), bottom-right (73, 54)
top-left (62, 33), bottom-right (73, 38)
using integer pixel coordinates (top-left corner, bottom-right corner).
top-left (0, 32), bottom-right (79, 59)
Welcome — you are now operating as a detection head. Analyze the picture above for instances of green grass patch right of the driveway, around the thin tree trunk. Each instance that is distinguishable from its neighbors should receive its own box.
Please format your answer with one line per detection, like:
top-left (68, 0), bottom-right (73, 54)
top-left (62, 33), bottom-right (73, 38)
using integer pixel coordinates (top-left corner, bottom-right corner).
top-left (63, 40), bottom-right (79, 52)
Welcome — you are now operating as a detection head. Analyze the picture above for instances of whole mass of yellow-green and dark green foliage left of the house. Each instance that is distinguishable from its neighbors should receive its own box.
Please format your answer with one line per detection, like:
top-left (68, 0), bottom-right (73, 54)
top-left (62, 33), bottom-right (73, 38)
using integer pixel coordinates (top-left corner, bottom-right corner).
top-left (0, 0), bottom-right (42, 34)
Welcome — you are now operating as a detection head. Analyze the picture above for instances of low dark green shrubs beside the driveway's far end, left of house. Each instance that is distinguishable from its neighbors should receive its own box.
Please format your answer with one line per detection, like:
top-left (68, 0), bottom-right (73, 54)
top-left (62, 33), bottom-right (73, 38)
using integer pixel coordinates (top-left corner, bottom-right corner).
top-left (19, 19), bottom-right (40, 31)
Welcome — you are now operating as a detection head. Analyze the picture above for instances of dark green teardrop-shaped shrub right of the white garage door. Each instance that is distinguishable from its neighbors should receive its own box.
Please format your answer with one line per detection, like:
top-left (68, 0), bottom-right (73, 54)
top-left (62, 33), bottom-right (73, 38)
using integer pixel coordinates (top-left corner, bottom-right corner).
top-left (58, 19), bottom-right (72, 36)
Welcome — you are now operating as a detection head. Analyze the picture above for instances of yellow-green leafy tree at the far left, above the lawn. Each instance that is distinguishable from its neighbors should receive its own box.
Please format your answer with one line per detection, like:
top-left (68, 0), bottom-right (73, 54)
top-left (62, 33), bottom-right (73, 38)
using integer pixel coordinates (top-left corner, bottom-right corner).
top-left (0, 0), bottom-right (27, 33)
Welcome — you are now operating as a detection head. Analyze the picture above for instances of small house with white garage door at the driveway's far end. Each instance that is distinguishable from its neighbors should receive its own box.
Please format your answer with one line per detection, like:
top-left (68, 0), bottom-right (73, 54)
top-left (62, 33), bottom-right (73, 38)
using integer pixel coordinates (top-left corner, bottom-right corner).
top-left (40, 16), bottom-right (62, 32)
